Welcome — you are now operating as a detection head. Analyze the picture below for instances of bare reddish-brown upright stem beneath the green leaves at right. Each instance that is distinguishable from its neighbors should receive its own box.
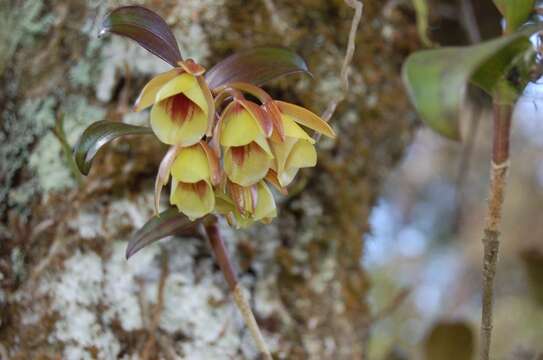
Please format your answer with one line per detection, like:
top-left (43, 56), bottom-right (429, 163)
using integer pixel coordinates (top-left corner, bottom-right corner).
top-left (480, 104), bottom-right (512, 360)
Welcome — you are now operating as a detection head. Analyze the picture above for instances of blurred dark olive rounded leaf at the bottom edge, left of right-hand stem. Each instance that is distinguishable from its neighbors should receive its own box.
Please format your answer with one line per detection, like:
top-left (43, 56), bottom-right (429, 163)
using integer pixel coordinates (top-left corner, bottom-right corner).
top-left (424, 321), bottom-right (475, 360)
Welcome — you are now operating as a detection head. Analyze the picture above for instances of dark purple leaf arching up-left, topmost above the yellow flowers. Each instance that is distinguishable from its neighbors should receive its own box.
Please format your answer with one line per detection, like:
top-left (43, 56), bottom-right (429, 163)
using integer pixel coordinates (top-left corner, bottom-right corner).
top-left (99, 6), bottom-right (183, 66)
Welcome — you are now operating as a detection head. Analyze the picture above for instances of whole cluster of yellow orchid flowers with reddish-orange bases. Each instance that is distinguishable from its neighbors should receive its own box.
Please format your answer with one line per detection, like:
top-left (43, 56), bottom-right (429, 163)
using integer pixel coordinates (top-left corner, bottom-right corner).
top-left (144, 59), bottom-right (334, 226)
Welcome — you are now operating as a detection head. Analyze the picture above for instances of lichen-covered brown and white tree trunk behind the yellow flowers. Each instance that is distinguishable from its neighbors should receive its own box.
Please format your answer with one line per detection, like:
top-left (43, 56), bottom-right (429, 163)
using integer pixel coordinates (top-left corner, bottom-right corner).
top-left (0, 0), bottom-right (417, 359)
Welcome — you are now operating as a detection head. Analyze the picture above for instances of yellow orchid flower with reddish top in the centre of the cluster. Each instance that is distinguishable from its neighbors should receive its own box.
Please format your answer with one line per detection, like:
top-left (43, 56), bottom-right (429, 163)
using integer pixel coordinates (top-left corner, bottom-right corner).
top-left (218, 100), bottom-right (273, 186)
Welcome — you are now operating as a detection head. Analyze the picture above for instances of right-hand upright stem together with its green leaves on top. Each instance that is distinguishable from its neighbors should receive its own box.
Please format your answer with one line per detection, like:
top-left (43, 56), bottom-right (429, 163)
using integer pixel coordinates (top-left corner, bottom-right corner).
top-left (403, 0), bottom-right (543, 360)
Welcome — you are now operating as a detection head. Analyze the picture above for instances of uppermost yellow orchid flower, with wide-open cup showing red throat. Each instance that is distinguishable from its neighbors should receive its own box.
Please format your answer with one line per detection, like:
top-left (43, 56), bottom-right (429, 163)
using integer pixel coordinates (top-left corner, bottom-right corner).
top-left (135, 60), bottom-right (215, 146)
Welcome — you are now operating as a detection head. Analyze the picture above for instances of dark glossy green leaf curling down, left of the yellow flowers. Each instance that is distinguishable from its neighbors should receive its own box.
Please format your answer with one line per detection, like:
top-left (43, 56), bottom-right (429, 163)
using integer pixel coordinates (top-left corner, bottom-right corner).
top-left (74, 120), bottom-right (153, 175)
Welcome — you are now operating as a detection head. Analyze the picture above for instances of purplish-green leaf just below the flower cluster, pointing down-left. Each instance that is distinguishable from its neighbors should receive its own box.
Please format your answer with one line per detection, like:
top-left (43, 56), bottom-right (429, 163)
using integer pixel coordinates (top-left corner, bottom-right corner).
top-left (126, 207), bottom-right (198, 259)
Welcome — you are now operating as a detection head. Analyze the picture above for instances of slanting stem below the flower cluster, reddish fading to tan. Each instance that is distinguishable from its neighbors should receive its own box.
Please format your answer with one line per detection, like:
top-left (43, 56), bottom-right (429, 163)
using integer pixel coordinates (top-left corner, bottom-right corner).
top-left (205, 220), bottom-right (273, 360)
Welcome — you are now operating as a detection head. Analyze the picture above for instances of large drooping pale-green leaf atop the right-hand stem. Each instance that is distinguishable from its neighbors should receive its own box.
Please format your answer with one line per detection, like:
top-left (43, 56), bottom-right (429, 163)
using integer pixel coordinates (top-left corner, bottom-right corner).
top-left (402, 27), bottom-right (537, 140)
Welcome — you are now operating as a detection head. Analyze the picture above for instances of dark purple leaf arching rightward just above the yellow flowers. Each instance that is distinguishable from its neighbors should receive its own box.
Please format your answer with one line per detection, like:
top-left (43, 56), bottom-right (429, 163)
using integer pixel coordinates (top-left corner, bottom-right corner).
top-left (206, 48), bottom-right (311, 89)
